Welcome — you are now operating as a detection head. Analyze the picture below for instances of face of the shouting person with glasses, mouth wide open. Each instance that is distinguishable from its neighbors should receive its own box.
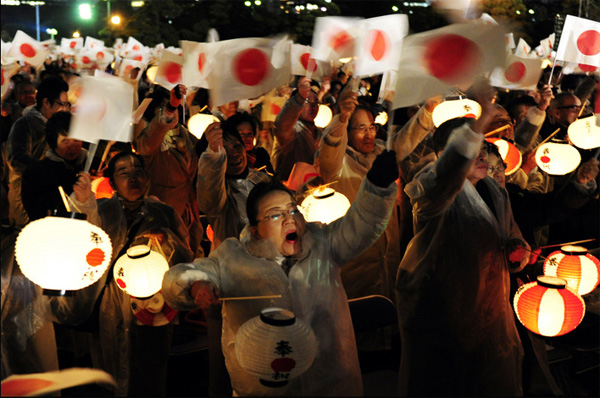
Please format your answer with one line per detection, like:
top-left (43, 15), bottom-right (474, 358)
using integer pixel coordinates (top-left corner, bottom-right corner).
top-left (251, 191), bottom-right (306, 256)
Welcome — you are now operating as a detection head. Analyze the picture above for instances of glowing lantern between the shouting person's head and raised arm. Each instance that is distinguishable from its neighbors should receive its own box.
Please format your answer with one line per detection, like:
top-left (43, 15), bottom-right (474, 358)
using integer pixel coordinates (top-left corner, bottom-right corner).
top-left (299, 187), bottom-right (350, 224)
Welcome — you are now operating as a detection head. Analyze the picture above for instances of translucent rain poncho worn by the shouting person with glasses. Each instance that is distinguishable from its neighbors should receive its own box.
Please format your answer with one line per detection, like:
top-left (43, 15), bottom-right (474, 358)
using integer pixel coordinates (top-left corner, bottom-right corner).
top-left (162, 179), bottom-right (397, 396)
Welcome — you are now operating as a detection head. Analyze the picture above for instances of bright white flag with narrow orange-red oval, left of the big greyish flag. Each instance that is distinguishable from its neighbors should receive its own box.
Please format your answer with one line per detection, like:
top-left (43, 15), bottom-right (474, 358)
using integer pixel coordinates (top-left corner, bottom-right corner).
top-left (354, 14), bottom-right (408, 77)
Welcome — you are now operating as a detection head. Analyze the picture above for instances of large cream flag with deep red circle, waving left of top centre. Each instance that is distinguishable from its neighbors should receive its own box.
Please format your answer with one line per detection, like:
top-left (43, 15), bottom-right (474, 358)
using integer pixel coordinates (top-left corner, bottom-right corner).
top-left (207, 36), bottom-right (291, 106)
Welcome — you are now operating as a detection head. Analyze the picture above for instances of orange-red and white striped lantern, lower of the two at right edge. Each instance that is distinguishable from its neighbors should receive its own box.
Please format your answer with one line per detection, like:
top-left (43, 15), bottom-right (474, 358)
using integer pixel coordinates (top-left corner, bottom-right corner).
top-left (513, 275), bottom-right (585, 337)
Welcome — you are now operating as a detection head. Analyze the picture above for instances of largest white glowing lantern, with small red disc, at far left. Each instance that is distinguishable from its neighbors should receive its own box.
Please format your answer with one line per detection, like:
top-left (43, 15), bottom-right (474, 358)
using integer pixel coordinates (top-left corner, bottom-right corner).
top-left (15, 213), bottom-right (112, 295)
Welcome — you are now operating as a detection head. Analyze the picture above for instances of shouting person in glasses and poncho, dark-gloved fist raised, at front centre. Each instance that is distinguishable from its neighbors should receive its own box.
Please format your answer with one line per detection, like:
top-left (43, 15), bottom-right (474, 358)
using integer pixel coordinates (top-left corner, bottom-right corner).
top-left (162, 151), bottom-right (398, 396)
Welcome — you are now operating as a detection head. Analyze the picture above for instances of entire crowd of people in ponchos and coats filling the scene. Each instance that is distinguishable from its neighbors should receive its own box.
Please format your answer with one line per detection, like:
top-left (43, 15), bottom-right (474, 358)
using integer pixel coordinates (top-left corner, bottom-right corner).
top-left (1, 35), bottom-right (600, 396)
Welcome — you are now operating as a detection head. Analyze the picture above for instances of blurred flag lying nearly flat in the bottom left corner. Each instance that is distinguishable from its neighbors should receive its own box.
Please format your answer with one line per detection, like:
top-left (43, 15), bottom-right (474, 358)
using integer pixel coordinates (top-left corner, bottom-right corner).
top-left (2, 368), bottom-right (116, 397)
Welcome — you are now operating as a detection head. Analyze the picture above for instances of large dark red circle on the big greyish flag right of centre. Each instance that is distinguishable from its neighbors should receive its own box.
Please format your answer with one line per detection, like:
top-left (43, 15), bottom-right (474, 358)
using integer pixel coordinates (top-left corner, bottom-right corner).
top-left (423, 34), bottom-right (481, 83)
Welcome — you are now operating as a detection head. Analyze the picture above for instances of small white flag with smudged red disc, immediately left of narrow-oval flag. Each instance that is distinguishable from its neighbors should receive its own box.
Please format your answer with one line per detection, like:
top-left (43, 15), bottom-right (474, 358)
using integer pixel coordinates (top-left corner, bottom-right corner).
top-left (312, 17), bottom-right (361, 61)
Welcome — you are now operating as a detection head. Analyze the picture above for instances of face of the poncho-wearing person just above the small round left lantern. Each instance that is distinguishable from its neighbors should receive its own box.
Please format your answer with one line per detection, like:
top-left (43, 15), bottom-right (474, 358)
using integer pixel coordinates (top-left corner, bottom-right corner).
top-left (113, 156), bottom-right (148, 202)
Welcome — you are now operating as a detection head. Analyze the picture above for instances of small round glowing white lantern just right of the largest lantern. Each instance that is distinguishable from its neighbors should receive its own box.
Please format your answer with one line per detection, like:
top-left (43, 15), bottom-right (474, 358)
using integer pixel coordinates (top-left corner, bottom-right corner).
top-left (113, 245), bottom-right (169, 298)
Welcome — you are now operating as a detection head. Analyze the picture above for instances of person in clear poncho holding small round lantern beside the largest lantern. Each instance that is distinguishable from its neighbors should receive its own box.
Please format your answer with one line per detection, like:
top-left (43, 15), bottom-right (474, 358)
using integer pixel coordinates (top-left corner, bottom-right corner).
top-left (71, 152), bottom-right (193, 396)
